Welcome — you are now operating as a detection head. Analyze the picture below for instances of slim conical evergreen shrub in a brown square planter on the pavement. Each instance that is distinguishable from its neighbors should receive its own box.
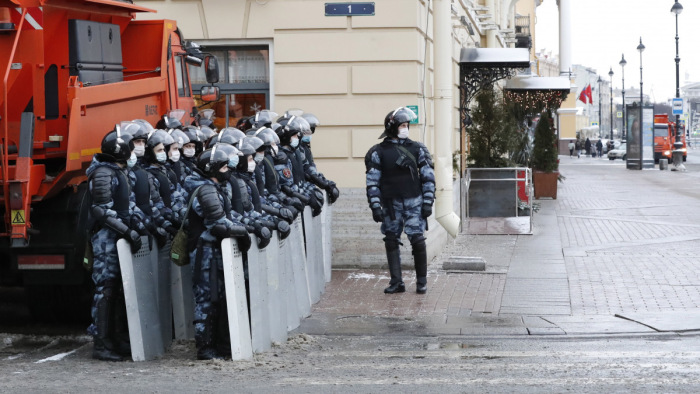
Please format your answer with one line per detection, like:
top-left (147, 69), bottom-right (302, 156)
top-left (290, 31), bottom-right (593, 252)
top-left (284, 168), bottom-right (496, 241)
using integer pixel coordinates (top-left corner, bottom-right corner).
top-left (531, 109), bottom-right (559, 199)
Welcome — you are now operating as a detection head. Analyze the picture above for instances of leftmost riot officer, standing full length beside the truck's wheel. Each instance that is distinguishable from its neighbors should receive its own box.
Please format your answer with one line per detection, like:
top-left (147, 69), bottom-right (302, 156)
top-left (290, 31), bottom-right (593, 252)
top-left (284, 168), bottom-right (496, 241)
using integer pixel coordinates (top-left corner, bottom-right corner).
top-left (86, 125), bottom-right (147, 361)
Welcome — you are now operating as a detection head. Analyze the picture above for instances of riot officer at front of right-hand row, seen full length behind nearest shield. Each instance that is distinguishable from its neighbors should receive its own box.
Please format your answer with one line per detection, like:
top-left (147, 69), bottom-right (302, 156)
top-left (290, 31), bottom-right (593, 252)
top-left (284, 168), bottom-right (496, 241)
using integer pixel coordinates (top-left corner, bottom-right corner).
top-left (185, 145), bottom-right (251, 360)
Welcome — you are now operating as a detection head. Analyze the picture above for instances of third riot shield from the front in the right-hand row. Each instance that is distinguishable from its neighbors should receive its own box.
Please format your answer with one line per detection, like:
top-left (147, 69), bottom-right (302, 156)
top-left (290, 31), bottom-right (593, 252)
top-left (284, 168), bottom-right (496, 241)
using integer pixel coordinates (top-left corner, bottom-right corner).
top-left (266, 231), bottom-right (287, 342)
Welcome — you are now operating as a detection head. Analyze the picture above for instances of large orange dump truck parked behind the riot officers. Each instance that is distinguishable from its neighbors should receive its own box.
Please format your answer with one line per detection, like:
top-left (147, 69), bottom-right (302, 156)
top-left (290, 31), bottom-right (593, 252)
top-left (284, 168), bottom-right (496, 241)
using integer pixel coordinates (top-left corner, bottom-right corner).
top-left (0, 0), bottom-right (218, 313)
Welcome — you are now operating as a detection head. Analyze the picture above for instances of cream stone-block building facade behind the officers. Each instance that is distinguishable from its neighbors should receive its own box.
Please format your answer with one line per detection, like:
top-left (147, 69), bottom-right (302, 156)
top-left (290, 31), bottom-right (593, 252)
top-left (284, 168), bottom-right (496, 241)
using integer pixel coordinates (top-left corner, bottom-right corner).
top-left (135, 0), bottom-right (539, 267)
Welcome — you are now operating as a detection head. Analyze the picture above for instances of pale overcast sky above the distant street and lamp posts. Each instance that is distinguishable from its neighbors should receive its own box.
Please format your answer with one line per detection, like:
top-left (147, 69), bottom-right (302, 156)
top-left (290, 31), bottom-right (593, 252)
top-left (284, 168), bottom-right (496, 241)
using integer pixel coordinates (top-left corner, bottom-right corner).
top-left (535, 0), bottom-right (700, 102)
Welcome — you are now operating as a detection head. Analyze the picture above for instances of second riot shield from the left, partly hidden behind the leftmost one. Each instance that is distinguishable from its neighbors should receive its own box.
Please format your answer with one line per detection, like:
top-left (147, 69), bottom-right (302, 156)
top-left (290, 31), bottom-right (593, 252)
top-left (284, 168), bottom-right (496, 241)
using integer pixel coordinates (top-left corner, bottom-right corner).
top-left (153, 241), bottom-right (173, 350)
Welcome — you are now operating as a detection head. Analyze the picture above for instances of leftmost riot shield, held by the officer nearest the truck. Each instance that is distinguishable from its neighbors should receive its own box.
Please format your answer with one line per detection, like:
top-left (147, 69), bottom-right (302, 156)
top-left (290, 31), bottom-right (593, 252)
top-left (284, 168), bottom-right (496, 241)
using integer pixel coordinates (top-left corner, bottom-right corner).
top-left (117, 237), bottom-right (164, 361)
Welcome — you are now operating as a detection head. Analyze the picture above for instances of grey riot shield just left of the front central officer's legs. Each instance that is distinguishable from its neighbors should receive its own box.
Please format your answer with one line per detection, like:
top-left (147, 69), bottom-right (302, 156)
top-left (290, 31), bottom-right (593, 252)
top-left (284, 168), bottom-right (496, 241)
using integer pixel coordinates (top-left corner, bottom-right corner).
top-left (170, 263), bottom-right (194, 339)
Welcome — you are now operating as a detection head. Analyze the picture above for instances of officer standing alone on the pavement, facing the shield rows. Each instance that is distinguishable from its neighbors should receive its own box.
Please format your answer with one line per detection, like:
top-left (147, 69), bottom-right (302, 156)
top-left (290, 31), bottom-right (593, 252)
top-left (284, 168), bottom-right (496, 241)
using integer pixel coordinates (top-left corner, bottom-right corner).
top-left (365, 107), bottom-right (435, 294)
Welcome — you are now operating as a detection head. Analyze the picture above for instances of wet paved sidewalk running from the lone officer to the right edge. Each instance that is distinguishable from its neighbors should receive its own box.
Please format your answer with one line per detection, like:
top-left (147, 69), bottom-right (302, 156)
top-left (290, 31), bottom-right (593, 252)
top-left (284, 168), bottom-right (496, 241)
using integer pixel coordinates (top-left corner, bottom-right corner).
top-left (298, 156), bottom-right (700, 336)
